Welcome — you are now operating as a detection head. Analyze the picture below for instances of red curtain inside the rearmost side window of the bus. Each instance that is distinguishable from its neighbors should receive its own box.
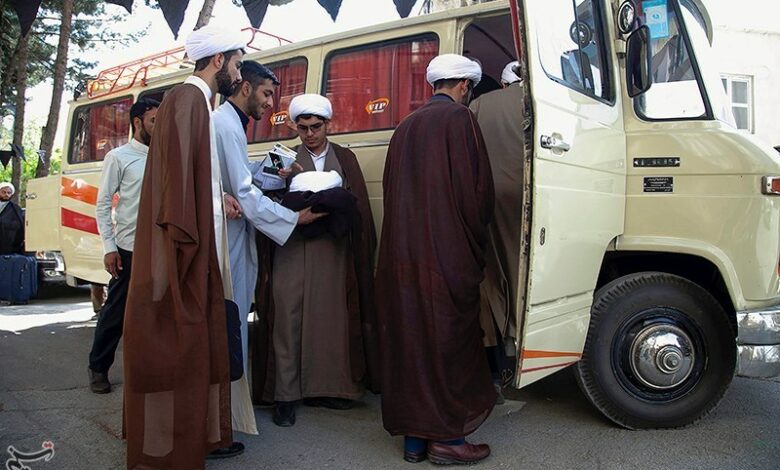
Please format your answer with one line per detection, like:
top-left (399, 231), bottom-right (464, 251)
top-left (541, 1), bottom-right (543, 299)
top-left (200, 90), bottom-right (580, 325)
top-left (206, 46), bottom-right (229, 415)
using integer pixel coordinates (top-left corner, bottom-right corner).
top-left (89, 98), bottom-right (133, 162)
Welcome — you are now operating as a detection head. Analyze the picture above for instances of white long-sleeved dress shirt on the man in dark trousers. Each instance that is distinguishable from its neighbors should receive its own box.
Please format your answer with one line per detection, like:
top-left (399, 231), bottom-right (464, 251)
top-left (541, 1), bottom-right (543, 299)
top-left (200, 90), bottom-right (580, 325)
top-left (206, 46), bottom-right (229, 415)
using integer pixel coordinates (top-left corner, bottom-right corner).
top-left (95, 139), bottom-right (149, 253)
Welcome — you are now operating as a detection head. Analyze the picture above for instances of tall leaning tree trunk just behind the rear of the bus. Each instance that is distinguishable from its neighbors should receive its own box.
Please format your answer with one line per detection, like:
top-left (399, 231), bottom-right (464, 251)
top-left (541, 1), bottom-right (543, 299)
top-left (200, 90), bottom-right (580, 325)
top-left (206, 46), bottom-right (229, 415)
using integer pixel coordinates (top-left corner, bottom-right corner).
top-left (35, 0), bottom-right (74, 178)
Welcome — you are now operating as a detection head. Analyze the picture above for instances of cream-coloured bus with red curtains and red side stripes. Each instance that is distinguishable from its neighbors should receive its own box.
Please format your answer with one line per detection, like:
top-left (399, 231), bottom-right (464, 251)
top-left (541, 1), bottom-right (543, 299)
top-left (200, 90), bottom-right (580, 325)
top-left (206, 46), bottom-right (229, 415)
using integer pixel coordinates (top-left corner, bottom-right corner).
top-left (26, 0), bottom-right (780, 428)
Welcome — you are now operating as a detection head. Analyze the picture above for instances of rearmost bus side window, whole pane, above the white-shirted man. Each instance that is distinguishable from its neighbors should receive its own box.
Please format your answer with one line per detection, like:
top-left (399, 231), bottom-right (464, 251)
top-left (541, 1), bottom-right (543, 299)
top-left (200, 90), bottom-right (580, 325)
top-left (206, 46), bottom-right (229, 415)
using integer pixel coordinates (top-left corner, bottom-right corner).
top-left (68, 97), bottom-right (133, 163)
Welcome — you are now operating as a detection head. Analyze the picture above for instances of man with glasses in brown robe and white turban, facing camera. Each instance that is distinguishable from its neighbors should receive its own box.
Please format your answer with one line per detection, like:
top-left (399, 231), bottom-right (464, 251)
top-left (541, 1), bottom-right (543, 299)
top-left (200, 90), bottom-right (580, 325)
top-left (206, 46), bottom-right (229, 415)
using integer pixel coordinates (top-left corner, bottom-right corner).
top-left (255, 94), bottom-right (378, 426)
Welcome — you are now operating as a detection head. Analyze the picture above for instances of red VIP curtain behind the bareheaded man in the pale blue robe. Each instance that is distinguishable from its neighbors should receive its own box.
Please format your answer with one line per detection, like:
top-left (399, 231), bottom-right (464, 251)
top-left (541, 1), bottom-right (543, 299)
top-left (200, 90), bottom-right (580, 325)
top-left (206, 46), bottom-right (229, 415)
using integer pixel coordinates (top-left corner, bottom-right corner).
top-left (251, 58), bottom-right (307, 144)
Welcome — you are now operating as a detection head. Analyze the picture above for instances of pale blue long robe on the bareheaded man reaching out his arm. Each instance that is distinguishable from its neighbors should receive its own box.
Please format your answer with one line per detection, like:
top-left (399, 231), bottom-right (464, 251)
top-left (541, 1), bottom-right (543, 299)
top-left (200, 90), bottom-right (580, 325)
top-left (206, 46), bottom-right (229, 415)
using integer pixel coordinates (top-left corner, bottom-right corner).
top-left (214, 102), bottom-right (298, 434)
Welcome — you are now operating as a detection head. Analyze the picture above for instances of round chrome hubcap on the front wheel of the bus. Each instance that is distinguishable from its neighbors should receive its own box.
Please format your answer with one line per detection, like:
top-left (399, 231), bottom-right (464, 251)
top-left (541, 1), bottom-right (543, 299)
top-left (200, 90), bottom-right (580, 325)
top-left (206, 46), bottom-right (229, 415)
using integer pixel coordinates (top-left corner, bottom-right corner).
top-left (630, 324), bottom-right (696, 390)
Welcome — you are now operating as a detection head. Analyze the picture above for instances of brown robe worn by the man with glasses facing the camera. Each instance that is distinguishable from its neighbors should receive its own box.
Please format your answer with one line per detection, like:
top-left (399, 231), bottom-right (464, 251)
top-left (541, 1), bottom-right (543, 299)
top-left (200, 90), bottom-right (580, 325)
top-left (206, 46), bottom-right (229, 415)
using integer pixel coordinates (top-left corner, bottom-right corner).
top-left (253, 142), bottom-right (379, 401)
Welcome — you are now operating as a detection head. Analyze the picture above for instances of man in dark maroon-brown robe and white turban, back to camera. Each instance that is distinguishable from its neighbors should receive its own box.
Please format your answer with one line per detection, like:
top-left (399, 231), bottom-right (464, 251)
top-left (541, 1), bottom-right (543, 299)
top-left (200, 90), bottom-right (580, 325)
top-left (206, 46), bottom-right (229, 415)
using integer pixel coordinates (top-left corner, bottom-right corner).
top-left (376, 54), bottom-right (496, 464)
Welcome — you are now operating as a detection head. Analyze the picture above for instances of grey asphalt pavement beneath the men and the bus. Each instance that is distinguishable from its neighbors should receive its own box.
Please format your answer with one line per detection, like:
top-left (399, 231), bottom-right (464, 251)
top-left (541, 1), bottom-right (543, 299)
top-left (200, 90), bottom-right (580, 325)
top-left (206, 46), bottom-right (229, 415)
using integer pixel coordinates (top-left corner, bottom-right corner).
top-left (0, 289), bottom-right (780, 470)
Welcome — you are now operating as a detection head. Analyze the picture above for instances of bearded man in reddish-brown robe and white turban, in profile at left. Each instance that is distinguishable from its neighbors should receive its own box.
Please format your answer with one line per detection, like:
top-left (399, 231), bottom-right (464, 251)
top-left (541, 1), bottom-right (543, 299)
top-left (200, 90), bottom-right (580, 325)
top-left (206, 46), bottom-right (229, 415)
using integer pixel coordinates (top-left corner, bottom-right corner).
top-left (124, 28), bottom-right (246, 470)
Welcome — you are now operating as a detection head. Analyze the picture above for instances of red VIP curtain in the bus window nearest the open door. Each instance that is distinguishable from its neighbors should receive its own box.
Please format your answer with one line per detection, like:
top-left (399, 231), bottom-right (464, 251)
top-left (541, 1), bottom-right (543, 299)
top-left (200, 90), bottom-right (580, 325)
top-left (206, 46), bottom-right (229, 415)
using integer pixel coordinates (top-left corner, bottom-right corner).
top-left (325, 36), bottom-right (439, 134)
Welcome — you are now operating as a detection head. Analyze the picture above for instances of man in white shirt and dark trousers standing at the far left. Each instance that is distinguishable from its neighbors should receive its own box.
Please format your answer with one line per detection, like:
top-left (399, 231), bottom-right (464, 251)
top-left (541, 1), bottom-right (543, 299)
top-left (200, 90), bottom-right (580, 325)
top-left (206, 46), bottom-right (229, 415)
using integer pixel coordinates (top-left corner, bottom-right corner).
top-left (89, 98), bottom-right (160, 393)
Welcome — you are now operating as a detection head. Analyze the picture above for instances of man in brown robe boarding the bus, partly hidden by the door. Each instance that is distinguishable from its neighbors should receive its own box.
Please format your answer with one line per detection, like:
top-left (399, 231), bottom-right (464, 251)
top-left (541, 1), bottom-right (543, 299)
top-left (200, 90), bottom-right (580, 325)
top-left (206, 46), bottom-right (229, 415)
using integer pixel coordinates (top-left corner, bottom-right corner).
top-left (469, 61), bottom-right (530, 400)
